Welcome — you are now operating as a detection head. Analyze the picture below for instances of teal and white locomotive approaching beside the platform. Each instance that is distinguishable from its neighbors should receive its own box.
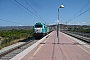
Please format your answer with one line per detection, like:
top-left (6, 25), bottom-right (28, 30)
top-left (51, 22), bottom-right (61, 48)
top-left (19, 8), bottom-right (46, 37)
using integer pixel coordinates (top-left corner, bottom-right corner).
top-left (33, 23), bottom-right (50, 38)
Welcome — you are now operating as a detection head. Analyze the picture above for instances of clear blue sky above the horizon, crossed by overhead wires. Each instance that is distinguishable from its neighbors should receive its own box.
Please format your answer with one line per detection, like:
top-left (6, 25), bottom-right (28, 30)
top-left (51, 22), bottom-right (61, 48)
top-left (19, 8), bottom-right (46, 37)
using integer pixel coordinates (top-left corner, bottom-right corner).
top-left (0, 0), bottom-right (90, 26)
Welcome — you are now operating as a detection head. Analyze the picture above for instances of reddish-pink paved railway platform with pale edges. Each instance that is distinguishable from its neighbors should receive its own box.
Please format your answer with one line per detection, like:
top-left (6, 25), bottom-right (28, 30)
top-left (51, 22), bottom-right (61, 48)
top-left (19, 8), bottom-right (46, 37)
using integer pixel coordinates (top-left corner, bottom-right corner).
top-left (11, 31), bottom-right (90, 60)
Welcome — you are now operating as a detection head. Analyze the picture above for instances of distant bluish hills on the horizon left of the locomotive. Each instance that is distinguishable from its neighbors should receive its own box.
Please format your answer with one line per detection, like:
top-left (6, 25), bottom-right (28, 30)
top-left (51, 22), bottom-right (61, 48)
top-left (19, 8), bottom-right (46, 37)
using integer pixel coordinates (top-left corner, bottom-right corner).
top-left (0, 26), bottom-right (33, 30)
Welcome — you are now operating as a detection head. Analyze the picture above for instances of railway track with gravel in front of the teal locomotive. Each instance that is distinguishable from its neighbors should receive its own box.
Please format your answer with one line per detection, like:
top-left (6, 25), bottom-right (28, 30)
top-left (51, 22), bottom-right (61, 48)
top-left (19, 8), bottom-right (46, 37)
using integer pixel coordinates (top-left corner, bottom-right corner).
top-left (0, 39), bottom-right (38, 60)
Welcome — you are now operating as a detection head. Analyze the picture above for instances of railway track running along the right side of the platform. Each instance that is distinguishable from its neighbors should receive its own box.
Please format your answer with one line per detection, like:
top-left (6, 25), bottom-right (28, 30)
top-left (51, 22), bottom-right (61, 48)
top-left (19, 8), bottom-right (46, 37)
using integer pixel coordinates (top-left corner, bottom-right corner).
top-left (62, 31), bottom-right (90, 44)
